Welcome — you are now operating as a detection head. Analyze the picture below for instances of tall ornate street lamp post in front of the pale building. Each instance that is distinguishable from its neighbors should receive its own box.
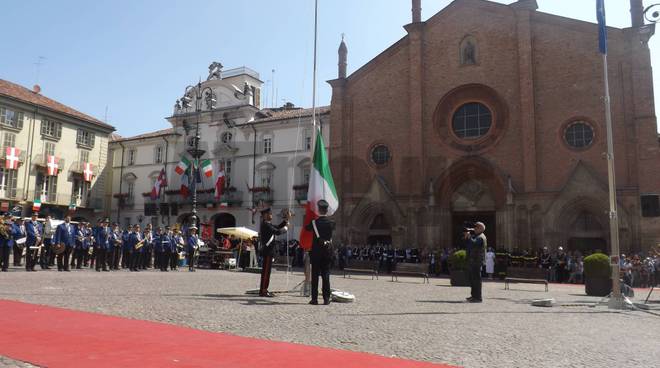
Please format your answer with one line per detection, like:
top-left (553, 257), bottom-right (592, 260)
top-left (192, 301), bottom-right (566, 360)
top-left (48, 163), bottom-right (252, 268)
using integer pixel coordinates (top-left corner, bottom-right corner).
top-left (180, 82), bottom-right (217, 226)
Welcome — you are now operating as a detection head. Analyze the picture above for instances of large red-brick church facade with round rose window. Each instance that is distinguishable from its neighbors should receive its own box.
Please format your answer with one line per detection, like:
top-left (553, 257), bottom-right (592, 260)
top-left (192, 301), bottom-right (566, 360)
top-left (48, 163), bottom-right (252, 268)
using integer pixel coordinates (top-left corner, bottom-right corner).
top-left (329, 0), bottom-right (660, 252)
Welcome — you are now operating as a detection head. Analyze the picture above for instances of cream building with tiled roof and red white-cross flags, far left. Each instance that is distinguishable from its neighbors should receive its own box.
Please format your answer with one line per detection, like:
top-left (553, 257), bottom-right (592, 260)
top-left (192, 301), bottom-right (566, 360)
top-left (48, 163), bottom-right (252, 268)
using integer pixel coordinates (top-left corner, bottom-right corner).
top-left (0, 80), bottom-right (115, 220)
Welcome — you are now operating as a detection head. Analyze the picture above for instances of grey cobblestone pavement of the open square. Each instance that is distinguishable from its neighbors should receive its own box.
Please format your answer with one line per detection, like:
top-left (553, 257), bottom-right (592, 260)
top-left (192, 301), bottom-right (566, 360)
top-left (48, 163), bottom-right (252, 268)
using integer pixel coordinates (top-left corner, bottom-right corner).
top-left (0, 269), bottom-right (660, 367)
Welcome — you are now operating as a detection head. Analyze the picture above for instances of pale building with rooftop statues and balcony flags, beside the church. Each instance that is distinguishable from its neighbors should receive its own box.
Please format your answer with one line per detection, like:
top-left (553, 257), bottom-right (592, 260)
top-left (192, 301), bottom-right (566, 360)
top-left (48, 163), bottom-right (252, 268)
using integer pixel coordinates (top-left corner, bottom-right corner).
top-left (110, 63), bottom-right (329, 239)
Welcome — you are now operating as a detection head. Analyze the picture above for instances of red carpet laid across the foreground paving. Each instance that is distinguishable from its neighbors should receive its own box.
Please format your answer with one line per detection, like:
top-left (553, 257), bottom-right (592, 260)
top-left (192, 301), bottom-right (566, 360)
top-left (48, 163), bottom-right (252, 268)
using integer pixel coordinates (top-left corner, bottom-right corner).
top-left (0, 300), bottom-right (448, 368)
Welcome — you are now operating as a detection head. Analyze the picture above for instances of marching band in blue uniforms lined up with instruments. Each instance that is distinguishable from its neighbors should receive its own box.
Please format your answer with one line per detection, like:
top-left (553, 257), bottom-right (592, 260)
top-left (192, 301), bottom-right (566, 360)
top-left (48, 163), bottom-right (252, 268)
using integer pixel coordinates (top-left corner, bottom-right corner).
top-left (0, 212), bottom-right (200, 272)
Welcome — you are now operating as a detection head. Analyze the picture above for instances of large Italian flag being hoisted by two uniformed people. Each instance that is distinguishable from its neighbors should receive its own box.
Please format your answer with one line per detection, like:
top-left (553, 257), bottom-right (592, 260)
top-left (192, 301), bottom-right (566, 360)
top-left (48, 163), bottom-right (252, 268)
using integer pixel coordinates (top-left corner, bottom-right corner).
top-left (300, 131), bottom-right (339, 250)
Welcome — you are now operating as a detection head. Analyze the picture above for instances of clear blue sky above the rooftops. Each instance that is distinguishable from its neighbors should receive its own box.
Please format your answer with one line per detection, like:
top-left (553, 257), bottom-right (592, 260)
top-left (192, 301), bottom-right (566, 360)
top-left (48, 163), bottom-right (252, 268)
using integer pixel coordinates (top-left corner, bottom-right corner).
top-left (0, 0), bottom-right (660, 136)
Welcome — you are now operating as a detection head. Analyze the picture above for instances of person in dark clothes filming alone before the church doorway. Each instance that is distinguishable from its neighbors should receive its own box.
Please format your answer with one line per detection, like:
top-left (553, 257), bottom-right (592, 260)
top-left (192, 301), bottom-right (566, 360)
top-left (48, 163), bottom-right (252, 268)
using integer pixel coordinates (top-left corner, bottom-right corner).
top-left (464, 222), bottom-right (488, 303)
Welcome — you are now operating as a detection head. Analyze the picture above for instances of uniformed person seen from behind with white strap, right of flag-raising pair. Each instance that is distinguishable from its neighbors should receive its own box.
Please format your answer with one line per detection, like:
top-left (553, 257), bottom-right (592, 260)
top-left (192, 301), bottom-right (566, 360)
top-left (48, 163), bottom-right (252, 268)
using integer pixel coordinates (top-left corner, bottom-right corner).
top-left (305, 199), bottom-right (335, 305)
